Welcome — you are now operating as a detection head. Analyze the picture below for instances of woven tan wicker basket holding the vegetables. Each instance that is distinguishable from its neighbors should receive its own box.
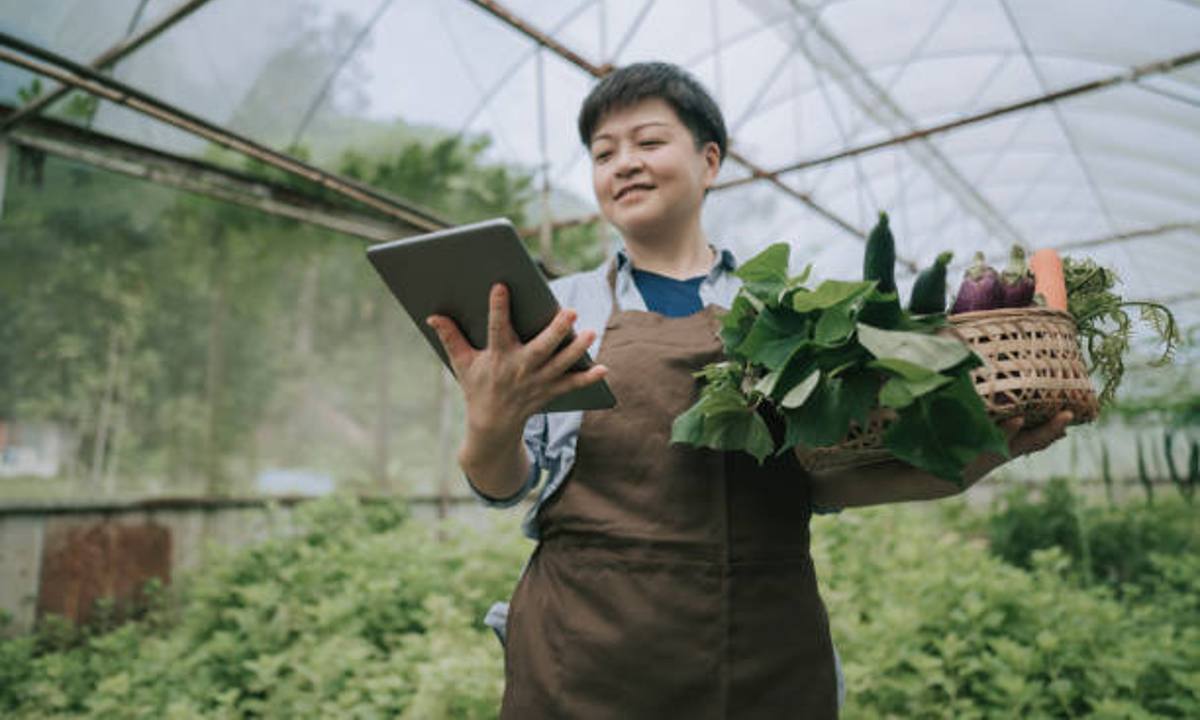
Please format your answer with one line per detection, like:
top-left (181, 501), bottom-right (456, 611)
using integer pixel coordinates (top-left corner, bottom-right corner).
top-left (799, 307), bottom-right (1100, 472)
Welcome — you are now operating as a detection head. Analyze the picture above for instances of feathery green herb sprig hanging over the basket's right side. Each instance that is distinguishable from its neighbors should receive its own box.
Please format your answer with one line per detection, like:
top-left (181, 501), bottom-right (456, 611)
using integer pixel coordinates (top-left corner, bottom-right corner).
top-left (1062, 257), bottom-right (1180, 406)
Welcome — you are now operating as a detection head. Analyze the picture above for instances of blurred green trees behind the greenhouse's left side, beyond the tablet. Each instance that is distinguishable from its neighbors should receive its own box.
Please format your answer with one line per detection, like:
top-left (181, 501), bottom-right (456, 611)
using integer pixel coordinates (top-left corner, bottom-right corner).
top-left (0, 114), bottom-right (605, 493)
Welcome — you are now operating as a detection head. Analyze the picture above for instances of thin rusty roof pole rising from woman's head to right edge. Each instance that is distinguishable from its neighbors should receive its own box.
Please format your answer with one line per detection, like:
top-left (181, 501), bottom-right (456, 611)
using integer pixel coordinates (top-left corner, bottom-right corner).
top-left (713, 50), bottom-right (1200, 191)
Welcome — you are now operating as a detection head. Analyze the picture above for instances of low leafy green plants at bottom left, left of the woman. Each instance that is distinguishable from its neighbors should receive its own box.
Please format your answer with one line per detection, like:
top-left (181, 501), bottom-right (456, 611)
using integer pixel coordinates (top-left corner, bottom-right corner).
top-left (0, 499), bottom-right (528, 719)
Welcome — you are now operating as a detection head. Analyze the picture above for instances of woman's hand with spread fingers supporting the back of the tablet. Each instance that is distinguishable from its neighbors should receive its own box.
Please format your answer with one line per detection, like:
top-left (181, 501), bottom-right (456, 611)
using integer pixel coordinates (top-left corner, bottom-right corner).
top-left (426, 284), bottom-right (607, 445)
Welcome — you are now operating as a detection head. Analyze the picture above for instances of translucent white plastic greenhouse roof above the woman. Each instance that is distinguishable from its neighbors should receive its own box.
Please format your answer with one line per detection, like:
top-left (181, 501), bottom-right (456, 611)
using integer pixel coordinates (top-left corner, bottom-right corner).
top-left (0, 0), bottom-right (1200, 355)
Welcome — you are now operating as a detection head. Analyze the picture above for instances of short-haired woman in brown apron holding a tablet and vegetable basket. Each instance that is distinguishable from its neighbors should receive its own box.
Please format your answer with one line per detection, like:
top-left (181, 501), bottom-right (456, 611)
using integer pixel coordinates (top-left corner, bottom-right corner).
top-left (430, 64), bottom-right (1070, 719)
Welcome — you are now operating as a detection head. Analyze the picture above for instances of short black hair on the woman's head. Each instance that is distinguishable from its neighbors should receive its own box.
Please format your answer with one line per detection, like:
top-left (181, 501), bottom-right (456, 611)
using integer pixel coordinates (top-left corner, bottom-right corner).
top-left (580, 62), bottom-right (728, 161)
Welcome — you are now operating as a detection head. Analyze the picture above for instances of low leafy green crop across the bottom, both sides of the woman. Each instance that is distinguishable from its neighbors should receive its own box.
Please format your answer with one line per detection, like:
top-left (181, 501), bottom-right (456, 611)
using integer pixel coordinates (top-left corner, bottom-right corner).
top-left (0, 491), bottom-right (1200, 720)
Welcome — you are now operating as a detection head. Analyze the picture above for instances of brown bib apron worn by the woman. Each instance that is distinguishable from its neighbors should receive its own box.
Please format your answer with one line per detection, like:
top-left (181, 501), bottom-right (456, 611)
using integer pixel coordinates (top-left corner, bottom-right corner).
top-left (500, 263), bottom-right (838, 720)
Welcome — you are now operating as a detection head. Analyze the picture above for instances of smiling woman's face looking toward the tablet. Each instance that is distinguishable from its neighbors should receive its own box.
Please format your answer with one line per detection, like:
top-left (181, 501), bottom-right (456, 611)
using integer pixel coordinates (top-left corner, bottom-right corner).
top-left (590, 97), bottom-right (720, 238)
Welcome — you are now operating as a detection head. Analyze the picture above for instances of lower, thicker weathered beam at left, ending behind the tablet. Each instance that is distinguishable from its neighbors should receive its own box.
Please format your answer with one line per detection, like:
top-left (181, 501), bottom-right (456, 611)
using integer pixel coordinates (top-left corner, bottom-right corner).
top-left (8, 107), bottom-right (421, 242)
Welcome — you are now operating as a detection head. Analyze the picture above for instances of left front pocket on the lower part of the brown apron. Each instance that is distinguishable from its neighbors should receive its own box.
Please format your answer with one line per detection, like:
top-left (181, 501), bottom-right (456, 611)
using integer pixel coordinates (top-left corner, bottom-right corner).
top-left (545, 553), bottom-right (725, 718)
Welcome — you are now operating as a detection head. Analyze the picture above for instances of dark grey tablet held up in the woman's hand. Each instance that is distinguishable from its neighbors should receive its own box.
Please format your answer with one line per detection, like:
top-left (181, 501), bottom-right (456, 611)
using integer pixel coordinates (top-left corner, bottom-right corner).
top-left (367, 218), bottom-right (617, 413)
